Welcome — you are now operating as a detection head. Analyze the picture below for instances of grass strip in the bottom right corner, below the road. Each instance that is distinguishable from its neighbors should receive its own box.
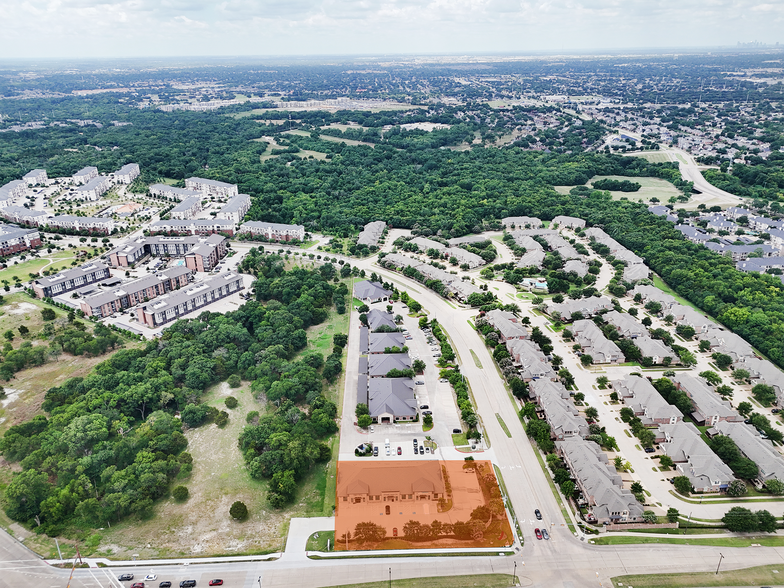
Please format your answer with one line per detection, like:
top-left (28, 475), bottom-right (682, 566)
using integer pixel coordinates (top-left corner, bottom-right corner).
top-left (612, 564), bottom-right (784, 588)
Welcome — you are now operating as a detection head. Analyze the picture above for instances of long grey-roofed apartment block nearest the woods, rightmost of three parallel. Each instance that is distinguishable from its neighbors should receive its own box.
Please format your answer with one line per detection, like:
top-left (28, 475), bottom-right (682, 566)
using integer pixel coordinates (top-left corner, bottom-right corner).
top-left (136, 272), bottom-right (244, 329)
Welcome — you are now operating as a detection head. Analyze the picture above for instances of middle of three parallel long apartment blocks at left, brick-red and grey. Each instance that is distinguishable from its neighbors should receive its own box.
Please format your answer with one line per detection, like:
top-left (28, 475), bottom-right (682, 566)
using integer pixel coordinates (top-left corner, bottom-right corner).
top-left (80, 266), bottom-right (192, 318)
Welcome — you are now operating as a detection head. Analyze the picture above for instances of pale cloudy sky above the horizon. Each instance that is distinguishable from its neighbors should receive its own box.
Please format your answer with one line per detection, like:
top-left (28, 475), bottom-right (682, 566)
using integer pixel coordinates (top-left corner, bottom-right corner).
top-left (0, 0), bottom-right (784, 59)
